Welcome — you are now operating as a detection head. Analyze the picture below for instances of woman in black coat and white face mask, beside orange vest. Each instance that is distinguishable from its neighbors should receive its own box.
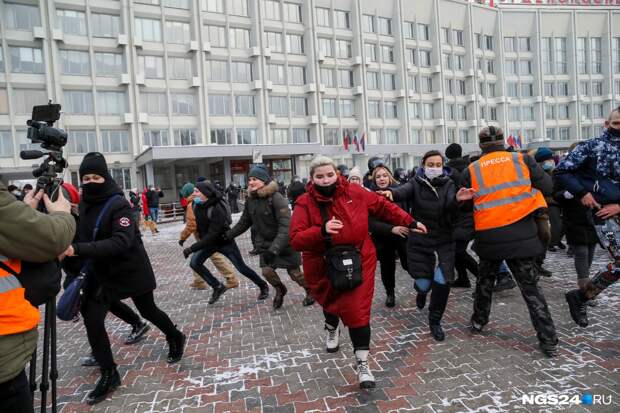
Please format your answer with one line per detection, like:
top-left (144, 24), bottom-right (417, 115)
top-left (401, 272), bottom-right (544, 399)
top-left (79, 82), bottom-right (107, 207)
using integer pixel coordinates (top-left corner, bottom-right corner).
top-left (386, 150), bottom-right (457, 341)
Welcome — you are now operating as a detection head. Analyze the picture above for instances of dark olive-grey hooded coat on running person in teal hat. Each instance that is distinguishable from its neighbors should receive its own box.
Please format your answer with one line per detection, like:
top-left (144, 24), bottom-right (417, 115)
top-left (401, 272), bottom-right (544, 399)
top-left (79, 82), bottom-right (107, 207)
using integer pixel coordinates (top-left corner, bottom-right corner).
top-left (226, 181), bottom-right (301, 269)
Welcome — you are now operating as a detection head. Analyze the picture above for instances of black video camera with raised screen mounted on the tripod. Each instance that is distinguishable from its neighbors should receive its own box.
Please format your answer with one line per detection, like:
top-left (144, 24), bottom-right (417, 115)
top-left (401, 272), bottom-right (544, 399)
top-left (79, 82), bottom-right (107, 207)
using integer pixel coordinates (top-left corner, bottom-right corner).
top-left (19, 101), bottom-right (67, 201)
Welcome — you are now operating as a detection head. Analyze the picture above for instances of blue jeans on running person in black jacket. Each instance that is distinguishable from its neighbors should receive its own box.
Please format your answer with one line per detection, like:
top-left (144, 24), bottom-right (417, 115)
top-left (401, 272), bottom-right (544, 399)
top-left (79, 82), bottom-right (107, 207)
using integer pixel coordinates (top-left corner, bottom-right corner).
top-left (189, 241), bottom-right (268, 289)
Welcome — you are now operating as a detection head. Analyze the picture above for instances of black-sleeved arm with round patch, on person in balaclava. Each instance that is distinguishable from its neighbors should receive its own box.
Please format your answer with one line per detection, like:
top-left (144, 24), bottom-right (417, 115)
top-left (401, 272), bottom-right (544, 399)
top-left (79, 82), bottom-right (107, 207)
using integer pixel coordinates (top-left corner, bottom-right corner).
top-left (68, 198), bottom-right (137, 258)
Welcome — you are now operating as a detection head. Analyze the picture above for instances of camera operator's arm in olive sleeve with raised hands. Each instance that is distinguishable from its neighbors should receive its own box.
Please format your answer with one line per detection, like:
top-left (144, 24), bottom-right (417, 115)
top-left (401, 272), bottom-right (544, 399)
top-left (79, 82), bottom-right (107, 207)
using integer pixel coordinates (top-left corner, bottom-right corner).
top-left (0, 182), bottom-right (75, 262)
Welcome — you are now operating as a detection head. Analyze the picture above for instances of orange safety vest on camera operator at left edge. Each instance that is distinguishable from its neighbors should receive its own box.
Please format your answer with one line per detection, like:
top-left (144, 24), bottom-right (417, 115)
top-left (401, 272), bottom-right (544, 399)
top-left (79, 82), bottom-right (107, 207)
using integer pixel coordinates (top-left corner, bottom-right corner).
top-left (0, 256), bottom-right (40, 336)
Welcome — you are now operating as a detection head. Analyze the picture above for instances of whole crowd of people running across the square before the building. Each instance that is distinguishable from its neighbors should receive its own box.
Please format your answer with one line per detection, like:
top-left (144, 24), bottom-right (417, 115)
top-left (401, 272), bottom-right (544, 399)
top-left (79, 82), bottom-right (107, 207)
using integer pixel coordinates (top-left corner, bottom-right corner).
top-left (0, 108), bottom-right (620, 411)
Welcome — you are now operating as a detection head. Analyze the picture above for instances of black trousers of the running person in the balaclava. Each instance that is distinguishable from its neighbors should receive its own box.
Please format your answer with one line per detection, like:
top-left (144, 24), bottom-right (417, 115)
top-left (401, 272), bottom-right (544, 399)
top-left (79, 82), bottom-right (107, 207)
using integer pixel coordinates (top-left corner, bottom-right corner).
top-left (81, 291), bottom-right (178, 369)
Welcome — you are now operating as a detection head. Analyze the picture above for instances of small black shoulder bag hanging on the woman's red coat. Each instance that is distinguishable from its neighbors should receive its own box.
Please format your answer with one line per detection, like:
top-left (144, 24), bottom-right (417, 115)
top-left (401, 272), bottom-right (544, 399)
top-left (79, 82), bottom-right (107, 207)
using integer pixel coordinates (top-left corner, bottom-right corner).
top-left (319, 203), bottom-right (362, 291)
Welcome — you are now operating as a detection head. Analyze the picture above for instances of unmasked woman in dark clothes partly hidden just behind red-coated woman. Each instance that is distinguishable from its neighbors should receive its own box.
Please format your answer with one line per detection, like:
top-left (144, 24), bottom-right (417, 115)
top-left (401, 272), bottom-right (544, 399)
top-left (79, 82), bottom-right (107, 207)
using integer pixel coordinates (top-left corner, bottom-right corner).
top-left (368, 165), bottom-right (409, 307)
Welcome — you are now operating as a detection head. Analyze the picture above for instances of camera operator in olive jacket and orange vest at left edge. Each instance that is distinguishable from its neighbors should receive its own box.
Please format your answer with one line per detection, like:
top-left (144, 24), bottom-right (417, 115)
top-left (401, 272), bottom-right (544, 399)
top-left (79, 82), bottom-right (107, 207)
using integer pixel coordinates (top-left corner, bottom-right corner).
top-left (0, 181), bottom-right (75, 413)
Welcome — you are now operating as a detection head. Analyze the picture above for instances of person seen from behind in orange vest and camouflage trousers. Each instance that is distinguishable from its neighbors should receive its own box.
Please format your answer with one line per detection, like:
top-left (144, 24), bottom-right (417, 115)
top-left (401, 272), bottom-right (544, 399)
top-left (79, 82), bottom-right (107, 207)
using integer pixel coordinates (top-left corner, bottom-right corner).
top-left (457, 126), bottom-right (558, 357)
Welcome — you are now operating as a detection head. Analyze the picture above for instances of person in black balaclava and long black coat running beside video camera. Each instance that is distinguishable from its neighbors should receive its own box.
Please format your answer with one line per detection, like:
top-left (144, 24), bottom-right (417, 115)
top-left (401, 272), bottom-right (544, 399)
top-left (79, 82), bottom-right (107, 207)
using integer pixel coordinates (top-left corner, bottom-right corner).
top-left (64, 152), bottom-right (186, 404)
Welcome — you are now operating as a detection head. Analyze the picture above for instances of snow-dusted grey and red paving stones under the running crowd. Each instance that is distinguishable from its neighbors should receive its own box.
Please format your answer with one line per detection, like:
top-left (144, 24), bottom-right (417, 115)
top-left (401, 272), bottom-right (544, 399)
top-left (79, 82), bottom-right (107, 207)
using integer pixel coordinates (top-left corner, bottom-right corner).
top-left (35, 219), bottom-right (620, 413)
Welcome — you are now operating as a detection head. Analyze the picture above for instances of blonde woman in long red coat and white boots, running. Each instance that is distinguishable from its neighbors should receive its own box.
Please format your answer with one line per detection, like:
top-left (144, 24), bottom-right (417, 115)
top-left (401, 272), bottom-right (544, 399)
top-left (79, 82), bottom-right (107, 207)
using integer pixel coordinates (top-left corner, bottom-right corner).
top-left (290, 156), bottom-right (426, 388)
